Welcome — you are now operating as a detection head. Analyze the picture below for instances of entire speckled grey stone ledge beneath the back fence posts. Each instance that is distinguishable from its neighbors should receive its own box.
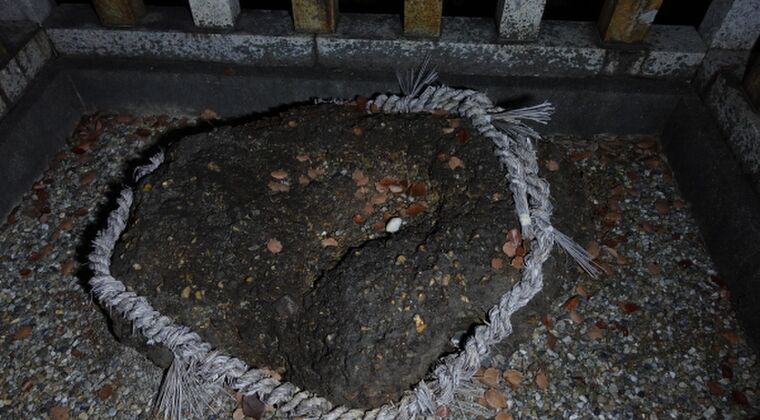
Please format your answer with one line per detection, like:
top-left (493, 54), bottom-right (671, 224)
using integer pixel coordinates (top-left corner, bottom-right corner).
top-left (45, 5), bottom-right (706, 80)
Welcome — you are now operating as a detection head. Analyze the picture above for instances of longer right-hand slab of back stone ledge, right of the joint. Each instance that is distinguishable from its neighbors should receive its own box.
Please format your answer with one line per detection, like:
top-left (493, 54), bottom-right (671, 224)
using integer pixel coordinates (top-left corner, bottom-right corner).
top-left (317, 14), bottom-right (705, 79)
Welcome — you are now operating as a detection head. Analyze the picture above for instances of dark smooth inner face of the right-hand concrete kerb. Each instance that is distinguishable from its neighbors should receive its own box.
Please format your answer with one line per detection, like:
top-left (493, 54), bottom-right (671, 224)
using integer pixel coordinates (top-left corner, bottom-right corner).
top-left (662, 95), bottom-right (760, 348)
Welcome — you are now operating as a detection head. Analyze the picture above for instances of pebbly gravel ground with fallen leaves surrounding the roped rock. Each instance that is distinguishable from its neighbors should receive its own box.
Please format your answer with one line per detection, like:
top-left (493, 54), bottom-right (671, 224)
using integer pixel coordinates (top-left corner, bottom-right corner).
top-left (0, 112), bottom-right (760, 420)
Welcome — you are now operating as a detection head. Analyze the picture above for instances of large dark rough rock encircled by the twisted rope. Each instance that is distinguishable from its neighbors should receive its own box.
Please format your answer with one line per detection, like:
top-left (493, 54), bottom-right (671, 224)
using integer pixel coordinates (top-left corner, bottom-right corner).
top-left (113, 105), bottom-right (590, 406)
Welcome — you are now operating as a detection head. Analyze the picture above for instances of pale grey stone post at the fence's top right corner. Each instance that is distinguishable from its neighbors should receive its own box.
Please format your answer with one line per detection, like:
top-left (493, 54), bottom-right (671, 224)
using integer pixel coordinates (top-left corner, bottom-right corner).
top-left (699, 0), bottom-right (760, 50)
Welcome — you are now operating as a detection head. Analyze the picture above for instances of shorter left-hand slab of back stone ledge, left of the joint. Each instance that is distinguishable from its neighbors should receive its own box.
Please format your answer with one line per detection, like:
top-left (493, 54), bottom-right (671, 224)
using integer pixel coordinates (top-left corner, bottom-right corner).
top-left (47, 5), bottom-right (314, 66)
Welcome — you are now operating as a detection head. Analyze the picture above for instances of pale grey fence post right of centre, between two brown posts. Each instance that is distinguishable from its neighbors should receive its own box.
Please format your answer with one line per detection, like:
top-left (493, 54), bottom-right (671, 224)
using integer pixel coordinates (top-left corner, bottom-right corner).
top-left (496, 0), bottom-right (546, 41)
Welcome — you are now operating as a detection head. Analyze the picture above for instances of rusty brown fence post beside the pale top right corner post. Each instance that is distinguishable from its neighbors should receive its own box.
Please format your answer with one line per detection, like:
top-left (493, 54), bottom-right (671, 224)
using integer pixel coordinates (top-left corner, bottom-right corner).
top-left (599, 0), bottom-right (662, 43)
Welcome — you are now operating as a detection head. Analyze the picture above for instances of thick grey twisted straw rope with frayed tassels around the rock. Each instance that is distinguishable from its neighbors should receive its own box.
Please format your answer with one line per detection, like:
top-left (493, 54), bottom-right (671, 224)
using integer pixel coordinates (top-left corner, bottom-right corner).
top-left (89, 75), bottom-right (596, 420)
